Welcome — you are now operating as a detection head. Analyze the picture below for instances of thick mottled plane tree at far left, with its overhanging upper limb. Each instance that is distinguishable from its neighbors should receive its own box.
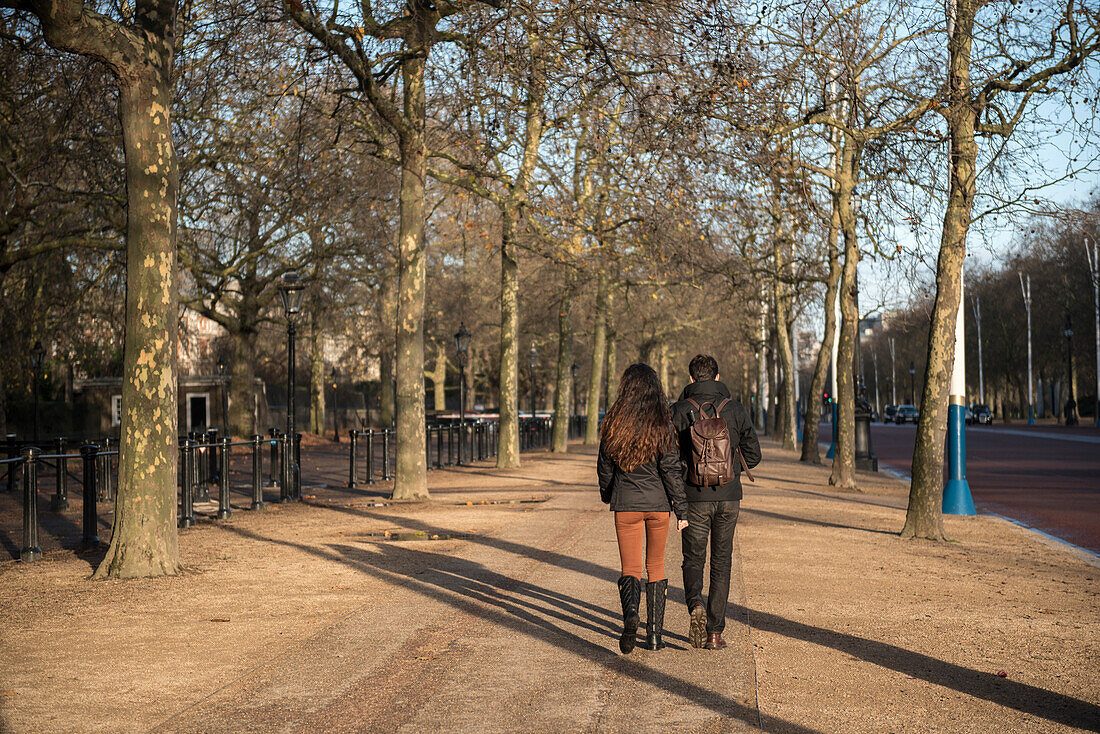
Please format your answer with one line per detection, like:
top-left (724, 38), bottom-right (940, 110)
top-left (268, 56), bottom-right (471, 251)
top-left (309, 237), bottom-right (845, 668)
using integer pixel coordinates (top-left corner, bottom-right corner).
top-left (0, 0), bottom-right (179, 578)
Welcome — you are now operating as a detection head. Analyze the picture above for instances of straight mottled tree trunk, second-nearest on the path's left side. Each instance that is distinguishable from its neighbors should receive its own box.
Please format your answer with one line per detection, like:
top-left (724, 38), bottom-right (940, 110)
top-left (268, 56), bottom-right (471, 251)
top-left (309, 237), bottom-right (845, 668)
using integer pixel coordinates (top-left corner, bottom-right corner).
top-left (391, 45), bottom-right (428, 500)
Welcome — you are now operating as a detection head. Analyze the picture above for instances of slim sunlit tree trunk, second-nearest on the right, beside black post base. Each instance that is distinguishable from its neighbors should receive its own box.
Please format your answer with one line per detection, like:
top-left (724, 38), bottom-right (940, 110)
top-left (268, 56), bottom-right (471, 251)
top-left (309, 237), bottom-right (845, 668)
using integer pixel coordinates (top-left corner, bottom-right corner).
top-left (828, 160), bottom-right (859, 490)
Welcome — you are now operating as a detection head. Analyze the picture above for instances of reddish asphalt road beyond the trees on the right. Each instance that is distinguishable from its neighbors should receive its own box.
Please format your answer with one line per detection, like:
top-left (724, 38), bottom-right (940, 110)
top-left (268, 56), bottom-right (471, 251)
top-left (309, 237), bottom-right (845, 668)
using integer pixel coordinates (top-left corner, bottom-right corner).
top-left (821, 424), bottom-right (1100, 554)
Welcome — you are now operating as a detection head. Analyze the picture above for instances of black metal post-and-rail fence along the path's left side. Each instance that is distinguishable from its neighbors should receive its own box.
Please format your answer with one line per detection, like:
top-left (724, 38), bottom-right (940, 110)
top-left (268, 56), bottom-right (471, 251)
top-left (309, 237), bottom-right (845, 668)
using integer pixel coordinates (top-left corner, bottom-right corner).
top-left (10, 416), bottom-right (567, 562)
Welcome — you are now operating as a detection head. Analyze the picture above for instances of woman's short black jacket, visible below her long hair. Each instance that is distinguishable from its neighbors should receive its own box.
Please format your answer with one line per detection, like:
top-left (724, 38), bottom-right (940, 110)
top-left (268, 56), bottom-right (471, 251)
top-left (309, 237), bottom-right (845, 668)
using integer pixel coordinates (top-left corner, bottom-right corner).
top-left (596, 446), bottom-right (688, 519)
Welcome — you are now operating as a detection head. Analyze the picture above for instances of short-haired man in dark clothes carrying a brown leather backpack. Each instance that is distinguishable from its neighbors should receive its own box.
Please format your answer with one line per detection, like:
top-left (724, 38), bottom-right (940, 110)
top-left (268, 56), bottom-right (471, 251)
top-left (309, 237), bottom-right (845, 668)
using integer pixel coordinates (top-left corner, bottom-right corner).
top-left (672, 354), bottom-right (760, 650)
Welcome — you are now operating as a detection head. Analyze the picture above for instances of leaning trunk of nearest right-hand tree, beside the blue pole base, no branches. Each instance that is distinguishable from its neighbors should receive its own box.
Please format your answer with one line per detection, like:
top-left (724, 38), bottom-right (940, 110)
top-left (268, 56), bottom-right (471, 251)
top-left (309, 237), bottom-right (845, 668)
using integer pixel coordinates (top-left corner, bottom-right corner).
top-left (901, 0), bottom-right (978, 540)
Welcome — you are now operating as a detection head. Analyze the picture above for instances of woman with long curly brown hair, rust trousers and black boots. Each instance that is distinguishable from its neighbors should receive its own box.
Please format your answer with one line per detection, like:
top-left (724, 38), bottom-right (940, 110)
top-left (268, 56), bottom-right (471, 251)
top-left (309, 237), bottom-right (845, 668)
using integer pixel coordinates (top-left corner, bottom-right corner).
top-left (596, 364), bottom-right (688, 654)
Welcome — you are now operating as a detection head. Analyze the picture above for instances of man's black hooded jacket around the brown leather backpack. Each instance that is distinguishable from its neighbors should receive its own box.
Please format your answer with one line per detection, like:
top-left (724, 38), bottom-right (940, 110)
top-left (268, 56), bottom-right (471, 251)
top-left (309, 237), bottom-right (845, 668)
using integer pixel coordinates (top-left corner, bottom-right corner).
top-left (672, 380), bottom-right (760, 502)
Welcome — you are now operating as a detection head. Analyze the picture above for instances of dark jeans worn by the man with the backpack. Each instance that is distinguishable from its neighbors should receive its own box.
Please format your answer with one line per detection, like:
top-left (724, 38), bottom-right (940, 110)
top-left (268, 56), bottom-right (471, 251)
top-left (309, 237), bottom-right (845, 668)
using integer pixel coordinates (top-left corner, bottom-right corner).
top-left (682, 501), bottom-right (741, 633)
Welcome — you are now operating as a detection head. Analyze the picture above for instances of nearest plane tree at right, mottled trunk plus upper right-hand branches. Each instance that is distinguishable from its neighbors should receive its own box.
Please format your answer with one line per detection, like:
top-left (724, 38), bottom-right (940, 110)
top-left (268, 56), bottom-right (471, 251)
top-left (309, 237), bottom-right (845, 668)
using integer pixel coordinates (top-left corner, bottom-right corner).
top-left (901, 0), bottom-right (1100, 540)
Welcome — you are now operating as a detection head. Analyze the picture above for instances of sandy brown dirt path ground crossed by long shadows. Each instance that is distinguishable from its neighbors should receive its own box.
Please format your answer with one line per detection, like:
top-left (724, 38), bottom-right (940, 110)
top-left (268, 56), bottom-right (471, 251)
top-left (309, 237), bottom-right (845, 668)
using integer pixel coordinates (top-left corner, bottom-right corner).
top-left (0, 442), bottom-right (1100, 733)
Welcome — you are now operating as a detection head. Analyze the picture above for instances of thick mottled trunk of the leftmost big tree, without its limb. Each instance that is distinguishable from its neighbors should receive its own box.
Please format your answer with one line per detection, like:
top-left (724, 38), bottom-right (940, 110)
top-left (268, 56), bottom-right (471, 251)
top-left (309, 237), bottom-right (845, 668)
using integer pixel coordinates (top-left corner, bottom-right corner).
top-left (96, 74), bottom-right (179, 578)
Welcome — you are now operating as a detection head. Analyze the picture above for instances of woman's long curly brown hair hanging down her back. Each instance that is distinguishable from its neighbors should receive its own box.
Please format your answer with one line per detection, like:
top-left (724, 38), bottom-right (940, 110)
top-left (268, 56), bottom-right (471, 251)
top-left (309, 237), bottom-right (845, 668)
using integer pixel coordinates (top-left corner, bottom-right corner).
top-left (600, 363), bottom-right (672, 472)
